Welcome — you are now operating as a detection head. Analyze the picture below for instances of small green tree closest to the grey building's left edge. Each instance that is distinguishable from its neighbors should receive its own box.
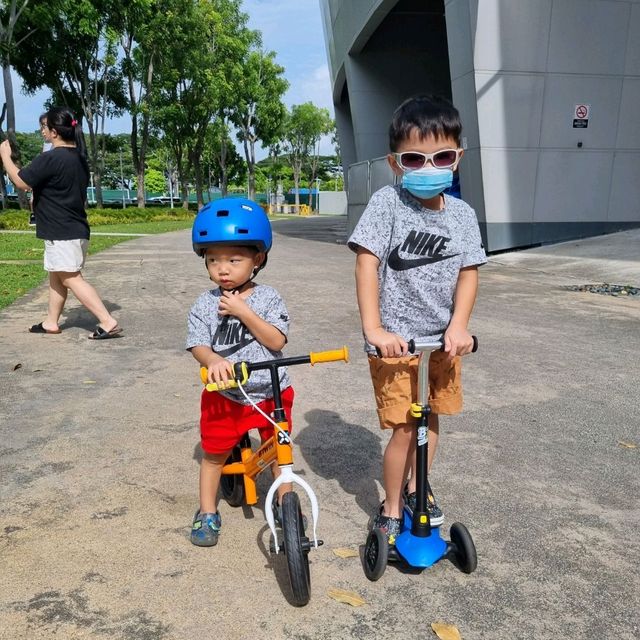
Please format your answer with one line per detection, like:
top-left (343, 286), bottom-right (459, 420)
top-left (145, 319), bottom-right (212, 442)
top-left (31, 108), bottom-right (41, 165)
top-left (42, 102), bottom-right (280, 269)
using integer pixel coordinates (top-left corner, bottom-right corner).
top-left (283, 102), bottom-right (333, 205)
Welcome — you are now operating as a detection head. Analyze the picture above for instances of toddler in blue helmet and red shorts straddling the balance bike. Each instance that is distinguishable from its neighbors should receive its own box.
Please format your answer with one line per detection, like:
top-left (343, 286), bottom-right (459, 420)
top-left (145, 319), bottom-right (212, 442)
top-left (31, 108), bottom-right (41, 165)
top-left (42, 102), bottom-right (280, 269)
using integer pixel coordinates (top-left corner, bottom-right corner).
top-left (186, 198), bottom-right (294, 547)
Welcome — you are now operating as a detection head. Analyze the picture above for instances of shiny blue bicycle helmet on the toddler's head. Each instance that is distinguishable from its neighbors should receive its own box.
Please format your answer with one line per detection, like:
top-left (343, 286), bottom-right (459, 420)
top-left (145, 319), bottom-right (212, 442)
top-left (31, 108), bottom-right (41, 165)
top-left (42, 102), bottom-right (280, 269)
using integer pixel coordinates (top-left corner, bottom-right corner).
top-left (191, 198), bottom-right (272, 256)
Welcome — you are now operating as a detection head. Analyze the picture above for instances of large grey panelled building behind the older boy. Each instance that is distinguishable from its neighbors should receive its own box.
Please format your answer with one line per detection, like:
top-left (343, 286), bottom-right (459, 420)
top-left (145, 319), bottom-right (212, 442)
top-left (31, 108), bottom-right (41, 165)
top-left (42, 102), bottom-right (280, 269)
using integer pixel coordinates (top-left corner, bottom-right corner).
top-left (320, 0), bottom-right (640, 254)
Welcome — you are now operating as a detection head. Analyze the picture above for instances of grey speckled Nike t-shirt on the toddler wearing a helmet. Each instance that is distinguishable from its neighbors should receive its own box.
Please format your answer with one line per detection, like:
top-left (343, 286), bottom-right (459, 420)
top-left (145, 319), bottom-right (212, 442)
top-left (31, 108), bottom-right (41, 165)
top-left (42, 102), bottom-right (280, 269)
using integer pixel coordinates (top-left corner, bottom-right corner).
top-left (186, 284), bottom-right (291, 404)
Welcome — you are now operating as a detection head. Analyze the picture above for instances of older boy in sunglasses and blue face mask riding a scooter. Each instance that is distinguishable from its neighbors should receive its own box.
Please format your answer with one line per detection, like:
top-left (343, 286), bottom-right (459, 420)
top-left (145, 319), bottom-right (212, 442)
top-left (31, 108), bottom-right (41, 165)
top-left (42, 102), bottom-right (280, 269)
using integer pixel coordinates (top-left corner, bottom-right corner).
top-left (349, 96), bottom-right (486, 551)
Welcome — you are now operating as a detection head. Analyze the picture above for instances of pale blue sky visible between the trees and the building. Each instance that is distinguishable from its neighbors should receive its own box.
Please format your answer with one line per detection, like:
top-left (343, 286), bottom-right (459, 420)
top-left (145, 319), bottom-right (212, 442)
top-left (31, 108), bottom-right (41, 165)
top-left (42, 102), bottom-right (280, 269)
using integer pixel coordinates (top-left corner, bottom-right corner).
top-left (0, 0), bottom-right (334, 158)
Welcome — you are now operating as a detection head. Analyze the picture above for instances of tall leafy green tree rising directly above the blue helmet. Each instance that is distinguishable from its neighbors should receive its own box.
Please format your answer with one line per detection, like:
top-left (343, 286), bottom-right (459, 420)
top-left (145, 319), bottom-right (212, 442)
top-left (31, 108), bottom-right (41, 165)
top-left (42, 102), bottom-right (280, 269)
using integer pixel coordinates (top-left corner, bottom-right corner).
top-left (230, 49), bottom-right (289, 199)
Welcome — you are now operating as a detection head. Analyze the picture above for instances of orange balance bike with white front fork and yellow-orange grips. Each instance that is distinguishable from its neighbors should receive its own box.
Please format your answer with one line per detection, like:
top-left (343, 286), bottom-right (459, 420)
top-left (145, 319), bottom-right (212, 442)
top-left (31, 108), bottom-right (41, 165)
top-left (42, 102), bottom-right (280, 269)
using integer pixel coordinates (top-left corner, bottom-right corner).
top-left (200, 347), bottom-right (349, 606)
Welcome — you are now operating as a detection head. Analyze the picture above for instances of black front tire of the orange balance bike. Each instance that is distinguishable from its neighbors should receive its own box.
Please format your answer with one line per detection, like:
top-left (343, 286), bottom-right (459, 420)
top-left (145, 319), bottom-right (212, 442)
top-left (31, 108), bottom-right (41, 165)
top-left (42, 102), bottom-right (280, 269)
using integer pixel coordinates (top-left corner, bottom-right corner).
top-left (282, 491), bottom-right (311, 607)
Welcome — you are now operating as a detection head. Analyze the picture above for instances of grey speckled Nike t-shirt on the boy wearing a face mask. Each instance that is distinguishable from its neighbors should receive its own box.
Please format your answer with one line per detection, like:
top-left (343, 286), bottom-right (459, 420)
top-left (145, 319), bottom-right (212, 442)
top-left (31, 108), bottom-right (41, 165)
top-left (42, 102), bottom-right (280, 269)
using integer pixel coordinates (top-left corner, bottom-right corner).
top-left (348, 185), bottom-right (487, 354)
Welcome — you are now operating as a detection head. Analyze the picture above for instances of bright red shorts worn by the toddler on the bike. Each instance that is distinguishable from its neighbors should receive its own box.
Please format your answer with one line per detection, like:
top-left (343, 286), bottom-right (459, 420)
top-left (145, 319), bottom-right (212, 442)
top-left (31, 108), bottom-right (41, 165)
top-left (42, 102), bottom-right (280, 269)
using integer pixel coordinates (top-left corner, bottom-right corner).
top-left (200, 387), bottom-right (295, 454)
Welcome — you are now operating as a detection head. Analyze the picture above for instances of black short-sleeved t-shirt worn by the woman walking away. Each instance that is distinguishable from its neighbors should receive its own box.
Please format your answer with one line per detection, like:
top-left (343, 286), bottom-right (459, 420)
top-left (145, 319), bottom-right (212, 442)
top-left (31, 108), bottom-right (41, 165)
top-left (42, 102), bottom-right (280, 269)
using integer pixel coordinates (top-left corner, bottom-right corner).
top-left (18, 147), bottom-right (89, 240)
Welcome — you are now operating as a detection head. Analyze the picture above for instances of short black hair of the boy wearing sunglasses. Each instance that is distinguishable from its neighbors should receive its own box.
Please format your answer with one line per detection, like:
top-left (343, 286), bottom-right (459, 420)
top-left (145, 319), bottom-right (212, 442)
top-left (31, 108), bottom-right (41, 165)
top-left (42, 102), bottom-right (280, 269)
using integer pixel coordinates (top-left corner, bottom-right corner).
top-left (389, 95), bottom-right (462, 151)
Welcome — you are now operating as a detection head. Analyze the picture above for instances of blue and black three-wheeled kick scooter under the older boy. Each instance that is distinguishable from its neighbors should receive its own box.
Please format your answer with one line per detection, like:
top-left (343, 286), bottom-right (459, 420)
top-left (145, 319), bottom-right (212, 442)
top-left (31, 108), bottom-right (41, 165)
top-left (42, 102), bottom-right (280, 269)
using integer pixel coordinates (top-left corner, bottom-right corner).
top-left (363, 336), bottom-right (478, 581)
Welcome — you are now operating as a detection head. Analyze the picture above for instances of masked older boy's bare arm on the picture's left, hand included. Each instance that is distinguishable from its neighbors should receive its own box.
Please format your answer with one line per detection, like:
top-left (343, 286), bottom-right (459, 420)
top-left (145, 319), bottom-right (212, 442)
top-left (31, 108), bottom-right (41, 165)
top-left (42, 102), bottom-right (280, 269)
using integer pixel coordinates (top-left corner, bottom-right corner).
top-left (356, 247), bottom-right (407, 358)
